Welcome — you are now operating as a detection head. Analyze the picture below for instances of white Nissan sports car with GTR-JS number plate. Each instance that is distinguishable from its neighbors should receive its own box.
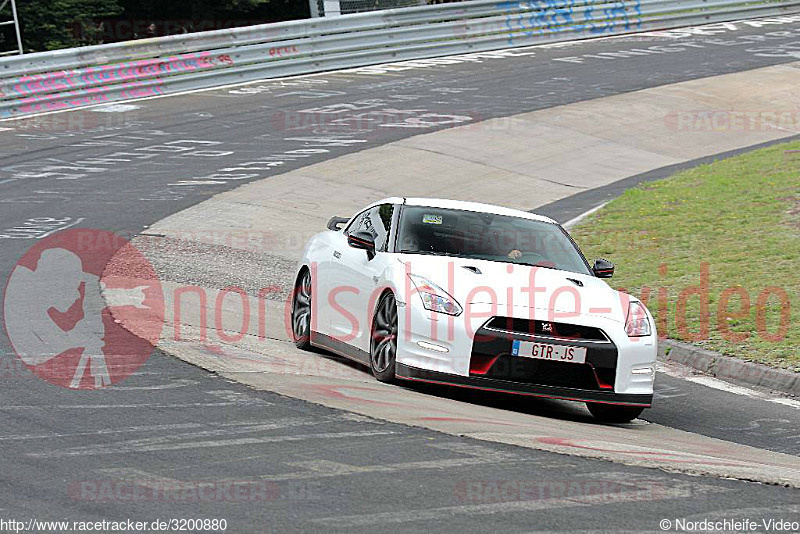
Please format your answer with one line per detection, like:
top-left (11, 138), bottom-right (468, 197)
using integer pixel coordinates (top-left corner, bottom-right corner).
top-left (291, 198), bottom-right (657, 422)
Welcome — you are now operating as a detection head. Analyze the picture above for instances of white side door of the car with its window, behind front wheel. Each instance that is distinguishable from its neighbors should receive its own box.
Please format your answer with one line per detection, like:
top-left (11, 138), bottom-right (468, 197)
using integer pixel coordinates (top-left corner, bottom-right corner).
top-left (329, 204), bottom-right (394, 352)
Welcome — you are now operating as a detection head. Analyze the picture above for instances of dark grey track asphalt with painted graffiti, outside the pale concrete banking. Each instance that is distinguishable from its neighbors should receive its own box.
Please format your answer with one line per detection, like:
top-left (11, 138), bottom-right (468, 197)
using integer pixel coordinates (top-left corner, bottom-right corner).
top-left (0, 18), bottom-right (800, 532)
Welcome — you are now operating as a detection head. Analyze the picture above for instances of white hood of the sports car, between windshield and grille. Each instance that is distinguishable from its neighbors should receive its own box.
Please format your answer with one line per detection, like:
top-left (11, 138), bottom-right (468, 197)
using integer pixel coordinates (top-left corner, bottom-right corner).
top-left (398, 254), bottom-right (636, 323)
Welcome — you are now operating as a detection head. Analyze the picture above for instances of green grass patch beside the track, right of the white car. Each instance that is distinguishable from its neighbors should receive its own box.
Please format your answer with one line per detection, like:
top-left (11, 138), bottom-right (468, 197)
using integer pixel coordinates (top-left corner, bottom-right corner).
top-left (571, 142), bottom-right (800, 371)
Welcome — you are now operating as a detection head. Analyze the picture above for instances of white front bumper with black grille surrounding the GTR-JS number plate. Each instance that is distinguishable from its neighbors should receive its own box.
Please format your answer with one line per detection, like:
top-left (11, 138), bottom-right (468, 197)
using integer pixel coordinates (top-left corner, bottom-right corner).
top-left (397, 306), bottom-right (656, 407)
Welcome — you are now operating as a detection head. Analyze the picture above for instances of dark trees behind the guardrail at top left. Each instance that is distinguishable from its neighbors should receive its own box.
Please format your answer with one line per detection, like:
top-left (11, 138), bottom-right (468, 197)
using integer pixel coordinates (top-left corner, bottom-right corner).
top-left (13, 0), bottom-right (310, 52)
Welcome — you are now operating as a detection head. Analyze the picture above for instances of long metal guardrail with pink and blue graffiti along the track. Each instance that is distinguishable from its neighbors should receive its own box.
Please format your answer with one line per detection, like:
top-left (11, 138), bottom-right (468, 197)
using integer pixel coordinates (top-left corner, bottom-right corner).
top-left (0, 0), bottom-right (800, 118)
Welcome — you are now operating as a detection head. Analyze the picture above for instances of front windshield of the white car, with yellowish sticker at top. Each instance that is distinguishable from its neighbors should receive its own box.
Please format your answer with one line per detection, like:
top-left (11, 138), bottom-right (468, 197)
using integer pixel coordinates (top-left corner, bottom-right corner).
top-left (397, 206), bottom-right (590, 274)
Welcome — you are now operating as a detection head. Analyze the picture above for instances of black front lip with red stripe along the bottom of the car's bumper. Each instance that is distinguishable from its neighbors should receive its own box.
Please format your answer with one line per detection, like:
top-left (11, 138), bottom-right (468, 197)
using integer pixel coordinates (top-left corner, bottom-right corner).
top-left (397, 363), bottom-right (653, 408)
